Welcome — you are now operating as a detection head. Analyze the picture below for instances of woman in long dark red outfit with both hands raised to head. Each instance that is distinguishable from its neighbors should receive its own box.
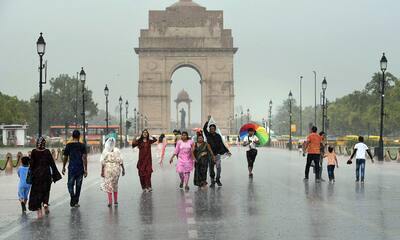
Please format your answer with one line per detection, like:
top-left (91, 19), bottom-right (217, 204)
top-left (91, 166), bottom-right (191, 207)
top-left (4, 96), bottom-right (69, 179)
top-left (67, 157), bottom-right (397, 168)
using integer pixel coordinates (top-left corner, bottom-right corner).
top-left (132, 129), bottom-right (157, 192)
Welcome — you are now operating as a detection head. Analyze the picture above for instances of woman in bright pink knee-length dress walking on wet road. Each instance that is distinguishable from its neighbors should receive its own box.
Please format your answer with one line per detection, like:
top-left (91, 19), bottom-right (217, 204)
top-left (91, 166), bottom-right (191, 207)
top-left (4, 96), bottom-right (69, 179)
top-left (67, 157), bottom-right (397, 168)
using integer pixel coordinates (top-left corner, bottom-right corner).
top-left (169, 132), bottom-right (195, 191)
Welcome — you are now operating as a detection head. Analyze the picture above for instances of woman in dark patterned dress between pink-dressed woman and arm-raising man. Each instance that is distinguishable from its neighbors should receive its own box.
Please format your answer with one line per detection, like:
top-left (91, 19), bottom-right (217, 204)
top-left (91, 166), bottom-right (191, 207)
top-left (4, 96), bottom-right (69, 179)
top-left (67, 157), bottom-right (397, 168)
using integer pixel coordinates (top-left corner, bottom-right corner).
top-left (194, 134), bottom-right (215, 188)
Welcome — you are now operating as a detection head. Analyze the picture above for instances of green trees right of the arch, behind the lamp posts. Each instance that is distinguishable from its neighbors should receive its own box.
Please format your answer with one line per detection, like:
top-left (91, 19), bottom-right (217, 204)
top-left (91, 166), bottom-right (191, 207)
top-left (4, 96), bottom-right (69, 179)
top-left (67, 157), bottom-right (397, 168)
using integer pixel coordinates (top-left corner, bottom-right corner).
top-left (272, 73), bottom-right (400, 137)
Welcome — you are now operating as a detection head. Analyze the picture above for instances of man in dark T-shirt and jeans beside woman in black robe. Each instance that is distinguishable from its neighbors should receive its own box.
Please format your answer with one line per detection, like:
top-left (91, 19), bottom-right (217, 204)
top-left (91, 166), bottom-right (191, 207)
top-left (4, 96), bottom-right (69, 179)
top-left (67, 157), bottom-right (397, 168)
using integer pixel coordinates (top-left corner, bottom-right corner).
top-left (62, 130), bottom-right (87, 207)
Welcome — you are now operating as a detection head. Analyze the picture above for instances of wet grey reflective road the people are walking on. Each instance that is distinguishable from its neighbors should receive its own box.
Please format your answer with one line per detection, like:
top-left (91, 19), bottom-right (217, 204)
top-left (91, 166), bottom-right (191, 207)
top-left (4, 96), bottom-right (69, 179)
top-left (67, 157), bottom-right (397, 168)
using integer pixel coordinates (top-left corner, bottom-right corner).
top-left (0, 148), bottom-right (400, 240)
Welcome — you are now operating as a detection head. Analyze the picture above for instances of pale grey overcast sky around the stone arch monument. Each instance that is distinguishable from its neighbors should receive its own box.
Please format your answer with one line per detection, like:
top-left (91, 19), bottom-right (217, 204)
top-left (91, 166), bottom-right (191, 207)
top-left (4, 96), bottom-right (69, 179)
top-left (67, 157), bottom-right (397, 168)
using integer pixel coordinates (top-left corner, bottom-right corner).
top-left (0, 0), bottom-right (400, 121)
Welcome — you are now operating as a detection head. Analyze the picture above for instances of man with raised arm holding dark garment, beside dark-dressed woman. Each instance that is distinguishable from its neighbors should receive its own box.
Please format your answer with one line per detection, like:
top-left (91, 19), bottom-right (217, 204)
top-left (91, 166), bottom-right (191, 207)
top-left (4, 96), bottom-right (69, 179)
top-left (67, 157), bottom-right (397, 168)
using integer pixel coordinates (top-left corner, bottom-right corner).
top-left (203, 116), bottom-right (231, 187)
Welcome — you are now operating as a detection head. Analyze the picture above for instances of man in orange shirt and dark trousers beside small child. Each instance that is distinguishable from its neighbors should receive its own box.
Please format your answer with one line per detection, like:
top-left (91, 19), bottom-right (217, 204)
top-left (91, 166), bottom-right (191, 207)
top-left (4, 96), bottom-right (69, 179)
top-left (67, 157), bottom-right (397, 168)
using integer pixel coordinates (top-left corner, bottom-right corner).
top-left (304, 126), bottom-right (322, 182)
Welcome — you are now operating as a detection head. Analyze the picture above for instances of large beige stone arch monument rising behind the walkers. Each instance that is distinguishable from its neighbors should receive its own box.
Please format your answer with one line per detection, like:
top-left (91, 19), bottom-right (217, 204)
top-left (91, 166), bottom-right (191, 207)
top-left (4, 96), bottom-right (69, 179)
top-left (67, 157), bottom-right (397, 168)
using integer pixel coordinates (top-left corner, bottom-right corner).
top-left (135, 0), bottom-right (237, 134)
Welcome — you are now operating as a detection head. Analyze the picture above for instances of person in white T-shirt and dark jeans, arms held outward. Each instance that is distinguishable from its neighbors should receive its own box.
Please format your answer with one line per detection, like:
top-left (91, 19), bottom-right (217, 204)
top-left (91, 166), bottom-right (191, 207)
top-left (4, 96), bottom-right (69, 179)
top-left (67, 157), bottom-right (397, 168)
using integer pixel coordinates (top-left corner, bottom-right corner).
top-left (347, 136), bottom-right (374, 183)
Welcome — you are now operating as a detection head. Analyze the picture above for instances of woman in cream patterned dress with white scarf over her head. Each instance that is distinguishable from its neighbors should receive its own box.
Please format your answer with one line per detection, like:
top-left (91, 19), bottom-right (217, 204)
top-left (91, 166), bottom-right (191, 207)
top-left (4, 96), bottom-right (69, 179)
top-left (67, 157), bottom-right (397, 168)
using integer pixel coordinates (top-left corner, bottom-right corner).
top-left (101, 137), bottom-right (125, 207)
